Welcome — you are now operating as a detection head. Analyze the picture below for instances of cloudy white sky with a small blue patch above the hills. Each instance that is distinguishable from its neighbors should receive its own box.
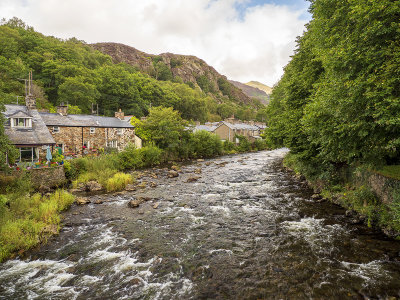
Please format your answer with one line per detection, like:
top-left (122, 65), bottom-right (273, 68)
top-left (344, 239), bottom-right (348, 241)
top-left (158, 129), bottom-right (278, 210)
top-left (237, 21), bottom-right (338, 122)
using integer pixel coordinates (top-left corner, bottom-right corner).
top-left (0, 0), bottom-right (311, 86)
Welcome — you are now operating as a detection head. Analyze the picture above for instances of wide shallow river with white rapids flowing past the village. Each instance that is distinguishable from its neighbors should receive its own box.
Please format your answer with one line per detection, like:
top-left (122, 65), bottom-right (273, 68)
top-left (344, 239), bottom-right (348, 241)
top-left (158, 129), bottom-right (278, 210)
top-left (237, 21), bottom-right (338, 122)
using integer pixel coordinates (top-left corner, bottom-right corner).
top-left (0, 149), bottom-right (400, 299)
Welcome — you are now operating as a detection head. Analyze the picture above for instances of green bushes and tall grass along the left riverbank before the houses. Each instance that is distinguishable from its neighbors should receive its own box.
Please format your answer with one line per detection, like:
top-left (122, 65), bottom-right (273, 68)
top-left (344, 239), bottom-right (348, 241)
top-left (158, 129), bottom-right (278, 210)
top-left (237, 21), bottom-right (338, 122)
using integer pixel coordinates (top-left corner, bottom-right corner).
top-left (0, 107), bottom-right (267, 262)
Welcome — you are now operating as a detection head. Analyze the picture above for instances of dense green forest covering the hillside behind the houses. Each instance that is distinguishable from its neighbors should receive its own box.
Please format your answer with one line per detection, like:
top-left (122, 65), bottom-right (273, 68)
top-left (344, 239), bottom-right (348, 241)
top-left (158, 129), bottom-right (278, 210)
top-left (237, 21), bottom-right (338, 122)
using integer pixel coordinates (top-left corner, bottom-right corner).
top-left (0, 18), bottom-right (265, 122)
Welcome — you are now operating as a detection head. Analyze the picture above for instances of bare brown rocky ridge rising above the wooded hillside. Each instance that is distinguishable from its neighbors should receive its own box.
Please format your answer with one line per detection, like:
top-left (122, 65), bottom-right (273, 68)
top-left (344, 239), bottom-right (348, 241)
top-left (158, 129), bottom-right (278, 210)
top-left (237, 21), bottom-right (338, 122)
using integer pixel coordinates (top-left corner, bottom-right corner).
top-left (91, 43), bottom-right (252, 104)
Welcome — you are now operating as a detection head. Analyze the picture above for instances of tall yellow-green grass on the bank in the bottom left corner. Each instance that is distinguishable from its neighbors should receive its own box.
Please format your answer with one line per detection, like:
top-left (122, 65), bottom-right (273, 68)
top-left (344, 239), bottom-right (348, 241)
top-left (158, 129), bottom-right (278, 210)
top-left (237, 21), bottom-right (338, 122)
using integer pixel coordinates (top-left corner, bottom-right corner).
top-left (0, 190), bottom-right (75, 262)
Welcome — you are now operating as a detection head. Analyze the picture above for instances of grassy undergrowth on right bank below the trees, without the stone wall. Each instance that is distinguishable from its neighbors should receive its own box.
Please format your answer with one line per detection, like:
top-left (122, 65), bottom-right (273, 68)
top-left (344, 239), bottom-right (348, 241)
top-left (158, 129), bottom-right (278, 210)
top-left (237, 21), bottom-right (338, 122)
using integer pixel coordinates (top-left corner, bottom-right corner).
top-left (284, 153), bottom-right (400, 238)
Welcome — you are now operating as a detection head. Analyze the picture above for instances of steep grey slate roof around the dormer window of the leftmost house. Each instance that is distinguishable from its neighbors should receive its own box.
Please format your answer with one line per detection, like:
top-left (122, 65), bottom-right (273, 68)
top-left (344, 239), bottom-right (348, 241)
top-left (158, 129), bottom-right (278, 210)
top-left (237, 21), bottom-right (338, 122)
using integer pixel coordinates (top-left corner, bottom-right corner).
top-left (4, 104), bottom-right (56, 146)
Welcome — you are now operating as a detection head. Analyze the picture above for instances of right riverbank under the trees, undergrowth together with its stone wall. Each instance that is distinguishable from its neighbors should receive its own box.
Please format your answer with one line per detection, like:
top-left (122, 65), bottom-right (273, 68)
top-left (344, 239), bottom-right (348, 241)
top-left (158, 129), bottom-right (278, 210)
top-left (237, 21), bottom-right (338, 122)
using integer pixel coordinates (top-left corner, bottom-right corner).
top-left (283, 153), bottom-right (400, 239)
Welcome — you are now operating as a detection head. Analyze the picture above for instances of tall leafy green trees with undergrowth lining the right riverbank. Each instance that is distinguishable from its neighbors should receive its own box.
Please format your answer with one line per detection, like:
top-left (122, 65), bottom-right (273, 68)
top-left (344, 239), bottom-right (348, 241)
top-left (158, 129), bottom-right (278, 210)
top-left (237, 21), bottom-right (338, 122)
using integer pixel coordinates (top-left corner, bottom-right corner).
top-left (266, 0), bottom-right (400, 237)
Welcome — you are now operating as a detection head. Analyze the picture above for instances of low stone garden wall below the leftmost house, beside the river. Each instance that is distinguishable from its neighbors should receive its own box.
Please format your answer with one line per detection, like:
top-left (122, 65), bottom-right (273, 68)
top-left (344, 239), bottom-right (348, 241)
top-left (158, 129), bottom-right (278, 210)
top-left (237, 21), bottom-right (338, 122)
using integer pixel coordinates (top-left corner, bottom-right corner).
top-left (28, 166), bottom-right (66, 189)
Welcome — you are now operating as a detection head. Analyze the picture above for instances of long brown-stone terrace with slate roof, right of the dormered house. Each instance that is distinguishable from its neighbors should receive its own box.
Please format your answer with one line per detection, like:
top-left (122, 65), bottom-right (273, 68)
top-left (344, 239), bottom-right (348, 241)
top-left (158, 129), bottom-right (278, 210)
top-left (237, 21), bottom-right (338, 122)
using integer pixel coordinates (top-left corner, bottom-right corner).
top-left (39, 105), bottom-right (142, 156)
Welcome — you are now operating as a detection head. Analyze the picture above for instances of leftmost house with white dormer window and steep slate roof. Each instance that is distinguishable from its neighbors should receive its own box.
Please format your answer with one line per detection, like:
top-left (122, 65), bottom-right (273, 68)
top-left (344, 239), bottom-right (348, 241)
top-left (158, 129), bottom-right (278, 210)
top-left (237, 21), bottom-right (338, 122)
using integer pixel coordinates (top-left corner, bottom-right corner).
top-left (4, 102), bottom-right (56, 162)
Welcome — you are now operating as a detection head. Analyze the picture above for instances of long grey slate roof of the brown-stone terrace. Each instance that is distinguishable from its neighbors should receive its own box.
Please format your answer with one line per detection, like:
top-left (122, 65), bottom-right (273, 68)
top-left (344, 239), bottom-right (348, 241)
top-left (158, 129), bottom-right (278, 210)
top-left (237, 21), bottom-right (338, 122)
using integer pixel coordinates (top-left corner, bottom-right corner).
top-left (40, 112), bottom-right (134, 128)
